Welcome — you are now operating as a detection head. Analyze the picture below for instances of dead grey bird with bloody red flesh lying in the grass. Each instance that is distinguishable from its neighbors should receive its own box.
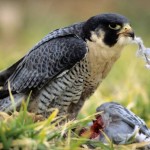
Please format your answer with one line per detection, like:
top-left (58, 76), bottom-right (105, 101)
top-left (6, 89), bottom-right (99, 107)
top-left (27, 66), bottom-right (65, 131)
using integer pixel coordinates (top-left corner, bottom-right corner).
top-left (78, 102), bottom-right (150, 150)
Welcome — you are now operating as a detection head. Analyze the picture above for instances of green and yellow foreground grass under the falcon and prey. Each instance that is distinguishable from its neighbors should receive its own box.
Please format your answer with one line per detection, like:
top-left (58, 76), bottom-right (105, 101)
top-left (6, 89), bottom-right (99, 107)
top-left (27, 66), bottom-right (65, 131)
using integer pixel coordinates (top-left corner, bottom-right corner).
top-left (0, 103), bottom-right (149, 150)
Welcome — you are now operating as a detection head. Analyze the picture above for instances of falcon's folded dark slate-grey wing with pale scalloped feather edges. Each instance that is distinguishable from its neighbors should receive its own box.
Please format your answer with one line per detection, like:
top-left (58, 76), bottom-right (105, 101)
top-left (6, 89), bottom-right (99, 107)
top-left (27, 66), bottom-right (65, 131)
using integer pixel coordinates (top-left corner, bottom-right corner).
top-left (5, 35), bottom-right (87, 92)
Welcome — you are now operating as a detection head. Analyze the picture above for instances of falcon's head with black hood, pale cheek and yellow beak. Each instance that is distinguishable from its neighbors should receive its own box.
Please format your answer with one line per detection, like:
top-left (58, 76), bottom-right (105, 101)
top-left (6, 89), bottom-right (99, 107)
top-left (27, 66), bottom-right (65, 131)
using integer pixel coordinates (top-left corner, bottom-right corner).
top-left (83, 13), bottom-right (134, 47)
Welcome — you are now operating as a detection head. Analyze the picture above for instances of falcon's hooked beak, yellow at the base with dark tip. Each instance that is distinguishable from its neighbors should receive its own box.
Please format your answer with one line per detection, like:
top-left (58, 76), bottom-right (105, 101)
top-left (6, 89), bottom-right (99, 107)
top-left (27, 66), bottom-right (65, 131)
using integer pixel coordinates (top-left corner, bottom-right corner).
top-left (118, 24), bottom-right (134, 39)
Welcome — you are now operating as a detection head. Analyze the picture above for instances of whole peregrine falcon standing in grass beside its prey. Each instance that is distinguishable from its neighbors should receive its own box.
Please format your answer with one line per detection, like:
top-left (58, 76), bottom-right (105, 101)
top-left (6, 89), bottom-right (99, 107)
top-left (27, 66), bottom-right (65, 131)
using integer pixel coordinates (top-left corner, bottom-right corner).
top-left (0, 13), bottom-right (134, 118)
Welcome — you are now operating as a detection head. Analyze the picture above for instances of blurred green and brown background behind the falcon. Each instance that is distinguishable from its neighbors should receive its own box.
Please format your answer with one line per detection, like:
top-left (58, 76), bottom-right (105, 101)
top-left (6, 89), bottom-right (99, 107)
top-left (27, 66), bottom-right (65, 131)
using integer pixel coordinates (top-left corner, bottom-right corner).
top-left (0, 0), bottom-right (150, 127)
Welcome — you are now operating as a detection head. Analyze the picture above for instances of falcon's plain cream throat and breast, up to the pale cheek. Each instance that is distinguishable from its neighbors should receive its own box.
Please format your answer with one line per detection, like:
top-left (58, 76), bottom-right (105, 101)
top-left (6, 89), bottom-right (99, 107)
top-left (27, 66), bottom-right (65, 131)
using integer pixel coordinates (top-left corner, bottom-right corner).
top-left (86, 32), bottom-right (132, 84)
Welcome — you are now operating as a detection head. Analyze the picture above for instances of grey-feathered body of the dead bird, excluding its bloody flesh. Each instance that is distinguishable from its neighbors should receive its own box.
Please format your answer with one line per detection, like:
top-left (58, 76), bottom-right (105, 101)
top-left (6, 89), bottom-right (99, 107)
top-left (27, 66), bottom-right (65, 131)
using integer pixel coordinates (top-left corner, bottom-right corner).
top-left (96, 102), bottom-right (150, 144)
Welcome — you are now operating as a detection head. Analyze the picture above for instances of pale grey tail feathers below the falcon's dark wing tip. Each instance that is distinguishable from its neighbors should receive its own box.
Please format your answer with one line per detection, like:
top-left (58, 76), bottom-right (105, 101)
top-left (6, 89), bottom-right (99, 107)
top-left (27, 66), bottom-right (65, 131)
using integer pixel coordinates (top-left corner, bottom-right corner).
top-left (0, 93), bottom-right (25, 112)
